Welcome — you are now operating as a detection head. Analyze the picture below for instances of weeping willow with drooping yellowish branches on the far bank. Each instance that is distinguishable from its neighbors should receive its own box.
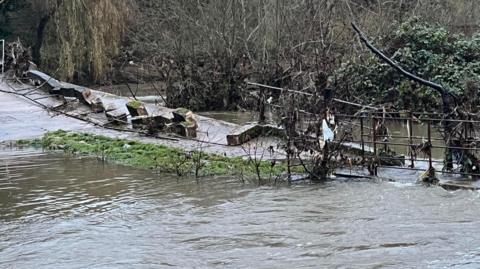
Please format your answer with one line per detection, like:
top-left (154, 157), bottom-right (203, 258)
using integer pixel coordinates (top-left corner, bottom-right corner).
top-left (33, 0), bottom-right (131, 82)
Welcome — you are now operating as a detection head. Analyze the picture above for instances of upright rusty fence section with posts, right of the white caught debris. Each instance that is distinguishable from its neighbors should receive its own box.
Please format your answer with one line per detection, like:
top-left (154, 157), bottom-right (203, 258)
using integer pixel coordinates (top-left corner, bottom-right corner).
top-left (336, 112), bottom-right (480, 177)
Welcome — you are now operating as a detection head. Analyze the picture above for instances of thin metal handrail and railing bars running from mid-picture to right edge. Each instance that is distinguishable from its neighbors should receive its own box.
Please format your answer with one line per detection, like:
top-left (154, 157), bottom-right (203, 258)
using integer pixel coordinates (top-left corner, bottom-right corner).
top-left (247, 82), bottom-right (480, 176)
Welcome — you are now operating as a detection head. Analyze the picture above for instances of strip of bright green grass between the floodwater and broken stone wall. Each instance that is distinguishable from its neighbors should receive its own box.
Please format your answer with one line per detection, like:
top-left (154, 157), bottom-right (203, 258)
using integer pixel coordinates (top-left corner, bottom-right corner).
top-left (42, 131), bottom-right (286, 177)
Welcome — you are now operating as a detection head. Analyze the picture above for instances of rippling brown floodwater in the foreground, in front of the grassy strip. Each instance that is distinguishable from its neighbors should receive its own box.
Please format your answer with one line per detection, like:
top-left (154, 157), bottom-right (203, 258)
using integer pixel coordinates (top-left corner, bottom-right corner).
top-left (0, 150), bottom-right (480, 268)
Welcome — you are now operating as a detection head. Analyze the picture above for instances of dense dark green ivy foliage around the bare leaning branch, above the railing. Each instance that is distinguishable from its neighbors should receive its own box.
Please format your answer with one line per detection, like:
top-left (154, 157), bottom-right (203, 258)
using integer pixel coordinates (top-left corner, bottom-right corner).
top-left (335, 20), bottom-right (480, 111)
